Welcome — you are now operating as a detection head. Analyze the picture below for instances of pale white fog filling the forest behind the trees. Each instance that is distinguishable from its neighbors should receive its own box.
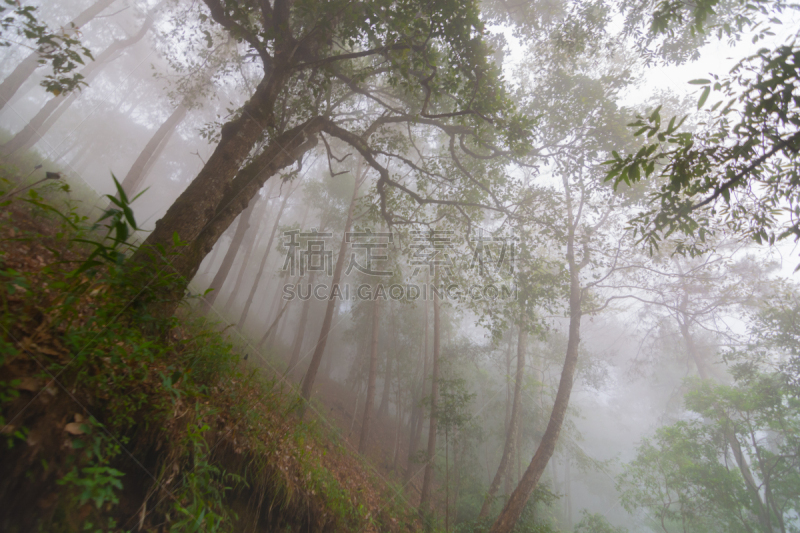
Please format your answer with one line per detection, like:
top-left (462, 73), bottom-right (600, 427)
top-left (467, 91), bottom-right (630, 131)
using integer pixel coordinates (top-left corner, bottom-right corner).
top-left (0, 0), bottom-right (800, 532)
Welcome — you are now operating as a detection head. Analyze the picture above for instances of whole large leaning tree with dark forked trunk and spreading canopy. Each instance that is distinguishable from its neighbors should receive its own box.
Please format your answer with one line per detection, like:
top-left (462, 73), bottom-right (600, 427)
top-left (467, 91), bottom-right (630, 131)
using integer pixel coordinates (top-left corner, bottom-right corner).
top-left (126, 0), bottom-right (529, 314)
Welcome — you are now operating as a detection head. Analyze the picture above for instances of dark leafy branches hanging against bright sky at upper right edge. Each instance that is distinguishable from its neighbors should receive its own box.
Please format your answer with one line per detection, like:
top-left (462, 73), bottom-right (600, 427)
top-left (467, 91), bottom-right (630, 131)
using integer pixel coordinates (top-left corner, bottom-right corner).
top-left (607, 2), bottom-right (800, 255)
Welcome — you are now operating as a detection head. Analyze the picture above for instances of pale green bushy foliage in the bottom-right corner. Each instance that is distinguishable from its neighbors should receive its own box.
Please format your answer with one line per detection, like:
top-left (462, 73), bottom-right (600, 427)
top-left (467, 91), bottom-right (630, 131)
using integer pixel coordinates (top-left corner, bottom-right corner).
top-left (619, 354), bottom-right (800, 532)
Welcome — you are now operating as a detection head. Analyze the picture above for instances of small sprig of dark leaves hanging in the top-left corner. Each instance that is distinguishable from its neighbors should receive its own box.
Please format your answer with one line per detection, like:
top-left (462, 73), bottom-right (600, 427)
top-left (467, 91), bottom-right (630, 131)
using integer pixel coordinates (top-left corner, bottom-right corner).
top-left (0, 0), bottom-right (94, 96)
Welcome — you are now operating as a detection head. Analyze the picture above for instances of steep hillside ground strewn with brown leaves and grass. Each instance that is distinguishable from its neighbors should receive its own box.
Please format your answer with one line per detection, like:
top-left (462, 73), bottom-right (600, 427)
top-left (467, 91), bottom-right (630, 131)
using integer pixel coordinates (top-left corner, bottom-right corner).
top-left (0, 160), bottom-right (432, 532)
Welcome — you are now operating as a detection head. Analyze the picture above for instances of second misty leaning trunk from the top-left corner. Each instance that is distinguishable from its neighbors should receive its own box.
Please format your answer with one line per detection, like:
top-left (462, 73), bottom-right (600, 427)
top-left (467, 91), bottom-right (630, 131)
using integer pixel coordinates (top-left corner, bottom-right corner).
top-left (0, 17), bottom-right (154, 157)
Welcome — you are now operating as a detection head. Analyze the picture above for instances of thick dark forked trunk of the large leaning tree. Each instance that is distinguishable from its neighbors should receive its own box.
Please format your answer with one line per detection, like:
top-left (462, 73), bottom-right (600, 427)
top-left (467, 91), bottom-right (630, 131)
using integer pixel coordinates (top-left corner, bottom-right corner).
top-left (129, 64), bottom-right (310, 308)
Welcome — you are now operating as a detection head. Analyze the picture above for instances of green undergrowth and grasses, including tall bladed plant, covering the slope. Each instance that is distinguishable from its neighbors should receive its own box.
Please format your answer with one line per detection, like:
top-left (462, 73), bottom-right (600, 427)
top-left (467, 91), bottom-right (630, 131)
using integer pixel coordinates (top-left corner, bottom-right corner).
top-left (0, 172), bottom-right (406, 532)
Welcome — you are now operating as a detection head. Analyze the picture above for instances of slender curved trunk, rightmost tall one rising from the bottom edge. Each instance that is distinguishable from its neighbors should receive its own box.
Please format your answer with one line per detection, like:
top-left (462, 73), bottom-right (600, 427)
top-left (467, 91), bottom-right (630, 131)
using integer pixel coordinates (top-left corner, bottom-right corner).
top-left (490, 262), bottom-right (582, 533)
